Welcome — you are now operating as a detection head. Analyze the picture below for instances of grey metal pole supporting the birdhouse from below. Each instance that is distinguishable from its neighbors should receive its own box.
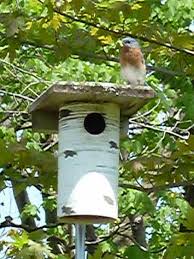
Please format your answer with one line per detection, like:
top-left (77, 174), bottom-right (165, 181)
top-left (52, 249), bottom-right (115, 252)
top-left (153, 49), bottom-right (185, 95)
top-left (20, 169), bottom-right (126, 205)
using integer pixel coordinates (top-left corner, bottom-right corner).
top-left (75, 224), bottom-right (86, 259)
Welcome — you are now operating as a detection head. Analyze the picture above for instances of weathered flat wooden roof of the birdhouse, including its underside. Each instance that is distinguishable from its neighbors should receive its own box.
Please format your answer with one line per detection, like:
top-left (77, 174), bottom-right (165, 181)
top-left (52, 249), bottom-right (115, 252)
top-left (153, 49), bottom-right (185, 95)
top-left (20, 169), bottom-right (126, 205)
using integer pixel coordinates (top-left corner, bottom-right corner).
top-left (29, 82), bottom-right (155, 132)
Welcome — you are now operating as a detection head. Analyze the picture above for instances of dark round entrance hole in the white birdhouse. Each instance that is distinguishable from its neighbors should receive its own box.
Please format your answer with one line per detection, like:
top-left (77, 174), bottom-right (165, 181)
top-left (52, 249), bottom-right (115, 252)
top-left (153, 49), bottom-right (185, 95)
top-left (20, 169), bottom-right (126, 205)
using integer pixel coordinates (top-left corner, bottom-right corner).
top-left (84, 112), bottom-right (106, 135)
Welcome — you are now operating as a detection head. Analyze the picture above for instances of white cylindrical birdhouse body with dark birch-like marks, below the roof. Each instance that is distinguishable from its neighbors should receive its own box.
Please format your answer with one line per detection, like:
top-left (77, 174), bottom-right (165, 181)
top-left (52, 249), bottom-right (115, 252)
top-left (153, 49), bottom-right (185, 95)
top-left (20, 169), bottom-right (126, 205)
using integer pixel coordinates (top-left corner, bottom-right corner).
top-left (57, 103), bottom-right (120, 223)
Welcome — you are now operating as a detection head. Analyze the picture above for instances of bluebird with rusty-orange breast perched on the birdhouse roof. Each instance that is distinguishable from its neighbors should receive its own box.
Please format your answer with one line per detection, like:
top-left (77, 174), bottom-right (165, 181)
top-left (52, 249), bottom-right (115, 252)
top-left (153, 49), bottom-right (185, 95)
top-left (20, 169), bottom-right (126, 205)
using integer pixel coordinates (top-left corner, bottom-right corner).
top-left (120, 37), bottom-right (146, 85)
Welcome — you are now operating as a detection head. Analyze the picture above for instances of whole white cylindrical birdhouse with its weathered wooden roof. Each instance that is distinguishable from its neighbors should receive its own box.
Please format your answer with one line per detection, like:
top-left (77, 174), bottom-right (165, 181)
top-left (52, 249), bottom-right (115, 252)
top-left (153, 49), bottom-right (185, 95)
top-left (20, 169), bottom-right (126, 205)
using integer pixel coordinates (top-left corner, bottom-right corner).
top-left (30, 82), bottom-right (154, 224)
